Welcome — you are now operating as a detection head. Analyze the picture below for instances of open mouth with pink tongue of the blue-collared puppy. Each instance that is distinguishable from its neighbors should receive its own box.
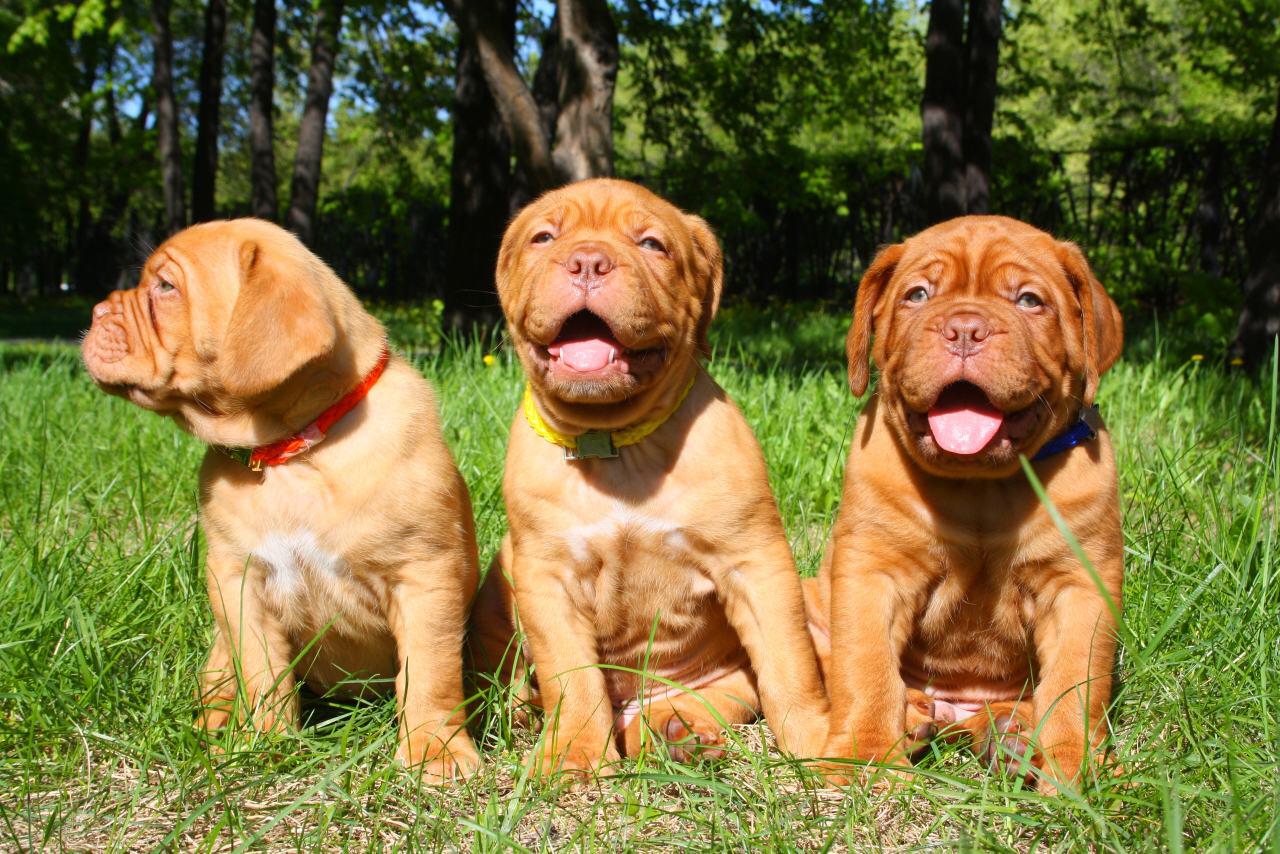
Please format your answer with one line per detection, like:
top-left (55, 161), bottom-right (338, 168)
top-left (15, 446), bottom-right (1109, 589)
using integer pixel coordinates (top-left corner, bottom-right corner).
top-left (918, 380), bottom-right (1039, 457)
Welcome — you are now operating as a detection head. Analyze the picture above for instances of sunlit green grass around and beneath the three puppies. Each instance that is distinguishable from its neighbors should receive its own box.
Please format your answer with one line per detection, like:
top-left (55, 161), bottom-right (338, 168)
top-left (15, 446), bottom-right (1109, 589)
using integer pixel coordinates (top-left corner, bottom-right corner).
top-left (0, 309), bottom-right (1280, 850)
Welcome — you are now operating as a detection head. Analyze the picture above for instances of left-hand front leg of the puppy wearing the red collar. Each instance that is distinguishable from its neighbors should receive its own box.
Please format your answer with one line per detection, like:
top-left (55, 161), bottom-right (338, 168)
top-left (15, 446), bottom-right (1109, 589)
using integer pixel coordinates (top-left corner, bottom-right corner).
top-left (202, 544), bottom-right (298, 730)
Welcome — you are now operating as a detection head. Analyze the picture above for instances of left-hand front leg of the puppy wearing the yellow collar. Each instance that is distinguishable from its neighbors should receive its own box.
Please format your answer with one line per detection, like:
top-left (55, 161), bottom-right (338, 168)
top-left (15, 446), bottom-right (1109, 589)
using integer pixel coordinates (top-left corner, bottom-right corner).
top-left (513, 549), bottom-right (620, 776)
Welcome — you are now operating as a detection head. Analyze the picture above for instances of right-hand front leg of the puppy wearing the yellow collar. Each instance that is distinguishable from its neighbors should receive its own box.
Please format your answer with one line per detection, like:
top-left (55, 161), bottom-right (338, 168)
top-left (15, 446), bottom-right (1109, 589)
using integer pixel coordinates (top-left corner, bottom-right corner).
top-left (716, 531), bottom-right (828, 758)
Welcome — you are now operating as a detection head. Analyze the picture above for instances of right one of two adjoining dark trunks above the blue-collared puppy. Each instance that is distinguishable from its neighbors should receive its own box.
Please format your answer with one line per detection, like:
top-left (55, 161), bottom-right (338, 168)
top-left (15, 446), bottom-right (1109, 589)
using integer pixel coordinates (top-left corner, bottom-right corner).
top-left (964, 0), bottom-right (1001, 214)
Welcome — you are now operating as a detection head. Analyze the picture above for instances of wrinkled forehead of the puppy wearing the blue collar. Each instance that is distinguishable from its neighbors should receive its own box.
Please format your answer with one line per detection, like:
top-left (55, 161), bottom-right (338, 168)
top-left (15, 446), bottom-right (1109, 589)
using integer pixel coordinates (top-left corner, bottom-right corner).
top-left (895, 225), bottom-right (1065, 294)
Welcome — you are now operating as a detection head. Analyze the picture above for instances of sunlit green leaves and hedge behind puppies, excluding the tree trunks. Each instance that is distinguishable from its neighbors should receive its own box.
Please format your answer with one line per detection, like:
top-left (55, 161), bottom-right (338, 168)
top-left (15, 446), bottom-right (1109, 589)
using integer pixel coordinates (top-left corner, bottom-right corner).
top-left (0, 0), bottom-right (1280, 350)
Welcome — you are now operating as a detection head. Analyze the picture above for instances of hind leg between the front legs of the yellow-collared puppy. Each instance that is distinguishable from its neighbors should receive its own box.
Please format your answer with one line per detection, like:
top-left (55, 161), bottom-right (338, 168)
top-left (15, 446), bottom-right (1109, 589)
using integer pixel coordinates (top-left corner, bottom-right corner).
top-left (620, 667), bottom-right (760, 763)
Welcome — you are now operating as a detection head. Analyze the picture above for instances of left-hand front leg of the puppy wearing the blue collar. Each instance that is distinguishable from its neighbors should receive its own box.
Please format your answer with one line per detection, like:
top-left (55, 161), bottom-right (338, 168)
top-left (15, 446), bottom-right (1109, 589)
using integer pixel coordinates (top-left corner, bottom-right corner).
top-left (823, 542), bottom-right (915, 784)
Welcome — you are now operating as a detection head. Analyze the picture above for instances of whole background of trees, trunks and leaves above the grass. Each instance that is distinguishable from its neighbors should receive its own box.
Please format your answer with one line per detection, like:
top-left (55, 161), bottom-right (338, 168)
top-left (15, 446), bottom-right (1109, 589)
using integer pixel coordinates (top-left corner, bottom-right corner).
top-left (0, 0), bottom-right (1280, 364)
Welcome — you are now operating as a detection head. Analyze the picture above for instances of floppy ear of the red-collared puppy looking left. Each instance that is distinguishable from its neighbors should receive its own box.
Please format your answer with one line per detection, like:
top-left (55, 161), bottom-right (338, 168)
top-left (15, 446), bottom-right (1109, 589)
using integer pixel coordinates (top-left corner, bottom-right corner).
top-left (218, 241), bottom-right (338, 397)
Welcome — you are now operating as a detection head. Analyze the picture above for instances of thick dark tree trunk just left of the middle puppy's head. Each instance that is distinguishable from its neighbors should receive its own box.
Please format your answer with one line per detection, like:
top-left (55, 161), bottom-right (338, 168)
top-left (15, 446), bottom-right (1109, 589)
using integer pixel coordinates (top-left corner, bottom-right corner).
top-left (444, 0), bottom-right (516, 329)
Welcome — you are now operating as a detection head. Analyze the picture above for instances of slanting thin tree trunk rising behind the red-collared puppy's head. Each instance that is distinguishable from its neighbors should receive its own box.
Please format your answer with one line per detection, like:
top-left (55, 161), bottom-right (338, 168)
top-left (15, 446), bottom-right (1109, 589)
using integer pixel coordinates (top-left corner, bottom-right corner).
top-left (285, 0), bottom-right (343, 246)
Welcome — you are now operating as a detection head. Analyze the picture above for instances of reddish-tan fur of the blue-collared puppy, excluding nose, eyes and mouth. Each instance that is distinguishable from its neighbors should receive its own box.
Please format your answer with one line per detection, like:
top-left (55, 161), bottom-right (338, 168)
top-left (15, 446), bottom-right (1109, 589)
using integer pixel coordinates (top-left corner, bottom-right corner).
top-left (805, 216), bottom-right (1124, 786)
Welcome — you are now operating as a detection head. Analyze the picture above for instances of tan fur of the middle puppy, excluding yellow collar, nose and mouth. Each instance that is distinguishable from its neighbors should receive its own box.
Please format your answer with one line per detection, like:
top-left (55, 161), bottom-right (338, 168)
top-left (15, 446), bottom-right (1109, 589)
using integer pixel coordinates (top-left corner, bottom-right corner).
top-left (474, 181), bottom-right (827, 773)
